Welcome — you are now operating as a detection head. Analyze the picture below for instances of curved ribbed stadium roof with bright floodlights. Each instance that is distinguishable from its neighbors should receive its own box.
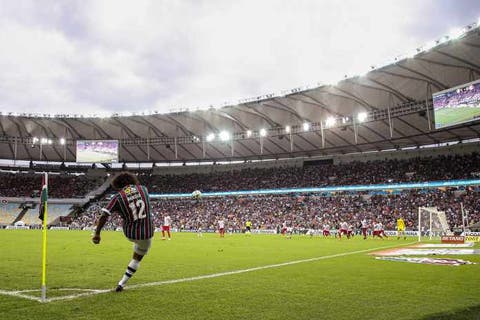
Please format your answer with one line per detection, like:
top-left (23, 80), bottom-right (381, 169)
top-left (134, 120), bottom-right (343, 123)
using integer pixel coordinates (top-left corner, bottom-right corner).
top-left (0, 23), bottom-right (480, 162)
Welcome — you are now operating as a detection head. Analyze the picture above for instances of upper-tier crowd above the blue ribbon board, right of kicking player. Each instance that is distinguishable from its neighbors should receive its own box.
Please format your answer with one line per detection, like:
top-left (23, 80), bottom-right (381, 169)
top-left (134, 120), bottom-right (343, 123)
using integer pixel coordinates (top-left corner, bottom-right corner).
top-left (142, 153), bottom-right (480, 193)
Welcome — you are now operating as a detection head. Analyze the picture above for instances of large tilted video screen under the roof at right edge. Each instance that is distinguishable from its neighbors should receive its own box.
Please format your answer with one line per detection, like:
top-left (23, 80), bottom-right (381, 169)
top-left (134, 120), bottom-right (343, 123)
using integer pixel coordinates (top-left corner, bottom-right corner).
top-left (433, 80), bottom-right (480, 129)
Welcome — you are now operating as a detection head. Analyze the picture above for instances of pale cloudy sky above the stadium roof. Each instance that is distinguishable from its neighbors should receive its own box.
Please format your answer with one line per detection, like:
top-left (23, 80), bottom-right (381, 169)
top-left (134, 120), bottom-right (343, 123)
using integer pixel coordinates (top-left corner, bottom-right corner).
top-left (0, 0), bottom-right (480, 114)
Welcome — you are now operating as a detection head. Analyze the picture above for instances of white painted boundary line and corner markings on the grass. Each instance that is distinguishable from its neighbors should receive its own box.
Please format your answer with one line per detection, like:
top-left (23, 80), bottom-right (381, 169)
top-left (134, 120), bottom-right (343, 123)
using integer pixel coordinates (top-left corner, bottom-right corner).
top-left (0, 241), bottom-right (417, 302)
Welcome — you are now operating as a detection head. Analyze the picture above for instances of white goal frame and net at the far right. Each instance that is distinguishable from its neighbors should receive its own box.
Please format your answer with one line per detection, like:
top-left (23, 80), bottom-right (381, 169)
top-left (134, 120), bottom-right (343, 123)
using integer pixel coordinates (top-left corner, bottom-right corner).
top-left (418, 207), bottom-right (450, 241)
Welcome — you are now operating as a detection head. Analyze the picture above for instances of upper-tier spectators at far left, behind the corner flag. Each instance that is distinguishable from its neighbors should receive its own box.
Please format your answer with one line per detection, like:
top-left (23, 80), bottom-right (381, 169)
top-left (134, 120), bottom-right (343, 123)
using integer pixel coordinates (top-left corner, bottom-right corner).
top-left (0, 173), bottom-right (103, 198)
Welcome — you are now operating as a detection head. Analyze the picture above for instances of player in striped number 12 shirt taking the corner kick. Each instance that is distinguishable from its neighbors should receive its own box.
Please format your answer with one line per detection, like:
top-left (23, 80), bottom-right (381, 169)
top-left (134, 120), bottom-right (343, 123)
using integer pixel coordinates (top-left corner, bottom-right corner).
top-left (92, 172), bottom-right (154, 292)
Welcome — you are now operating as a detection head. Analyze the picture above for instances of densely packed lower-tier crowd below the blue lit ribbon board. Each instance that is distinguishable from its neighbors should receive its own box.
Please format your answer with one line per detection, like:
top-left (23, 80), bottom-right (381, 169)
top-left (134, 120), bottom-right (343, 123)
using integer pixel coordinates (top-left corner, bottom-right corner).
top-left (74, 188), bottom-right (480, 231)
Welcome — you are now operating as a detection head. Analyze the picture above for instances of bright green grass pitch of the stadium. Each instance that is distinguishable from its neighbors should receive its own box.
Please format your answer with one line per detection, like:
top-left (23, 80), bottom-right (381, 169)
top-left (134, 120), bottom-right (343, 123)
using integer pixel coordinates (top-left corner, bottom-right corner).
top-left (0, 230), bottom-right (480, 320)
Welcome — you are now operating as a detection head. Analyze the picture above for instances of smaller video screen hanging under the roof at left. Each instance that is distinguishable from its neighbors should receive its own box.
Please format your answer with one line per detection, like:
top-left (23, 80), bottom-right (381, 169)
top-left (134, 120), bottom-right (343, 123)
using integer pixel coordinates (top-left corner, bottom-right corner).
top-left (77, 140), bottom-right (118, 163)
